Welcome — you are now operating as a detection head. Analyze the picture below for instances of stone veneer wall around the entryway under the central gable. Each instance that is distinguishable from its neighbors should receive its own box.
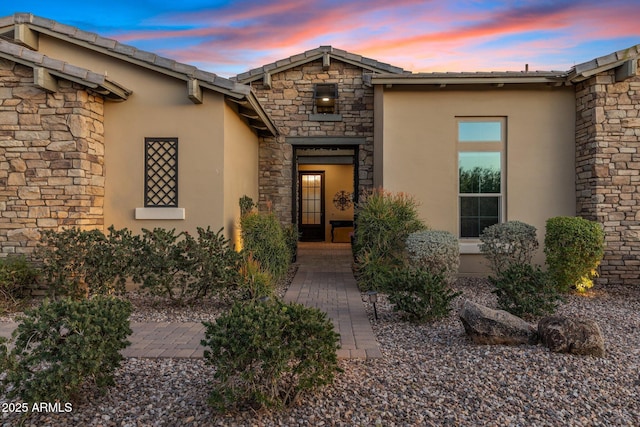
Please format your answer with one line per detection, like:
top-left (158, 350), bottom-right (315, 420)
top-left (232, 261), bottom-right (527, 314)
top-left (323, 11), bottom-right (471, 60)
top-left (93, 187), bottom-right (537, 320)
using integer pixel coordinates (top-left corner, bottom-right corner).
top-left (252, 60), bottom-right (373, 223)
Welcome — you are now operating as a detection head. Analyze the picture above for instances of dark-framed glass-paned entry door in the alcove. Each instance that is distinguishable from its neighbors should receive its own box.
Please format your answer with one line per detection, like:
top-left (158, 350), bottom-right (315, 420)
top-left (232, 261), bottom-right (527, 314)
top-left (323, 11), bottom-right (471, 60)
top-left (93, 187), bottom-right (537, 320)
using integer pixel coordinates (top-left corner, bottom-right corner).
top-left (298, 171), bottom-right (325, 241)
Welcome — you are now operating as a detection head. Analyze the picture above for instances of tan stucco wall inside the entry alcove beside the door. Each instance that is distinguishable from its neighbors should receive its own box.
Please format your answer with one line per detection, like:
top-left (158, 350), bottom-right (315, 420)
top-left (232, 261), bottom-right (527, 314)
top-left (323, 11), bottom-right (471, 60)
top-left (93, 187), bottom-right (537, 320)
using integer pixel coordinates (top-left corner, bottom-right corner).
top-left (298, 165), bottom-right (353, 243)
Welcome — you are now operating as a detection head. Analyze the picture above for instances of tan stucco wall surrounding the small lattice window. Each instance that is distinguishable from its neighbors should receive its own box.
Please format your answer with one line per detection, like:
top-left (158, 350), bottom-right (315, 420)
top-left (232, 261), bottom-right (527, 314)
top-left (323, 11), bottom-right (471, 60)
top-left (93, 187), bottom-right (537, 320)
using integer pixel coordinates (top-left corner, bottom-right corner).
top-left (33, 36), bottom-right (238, 237)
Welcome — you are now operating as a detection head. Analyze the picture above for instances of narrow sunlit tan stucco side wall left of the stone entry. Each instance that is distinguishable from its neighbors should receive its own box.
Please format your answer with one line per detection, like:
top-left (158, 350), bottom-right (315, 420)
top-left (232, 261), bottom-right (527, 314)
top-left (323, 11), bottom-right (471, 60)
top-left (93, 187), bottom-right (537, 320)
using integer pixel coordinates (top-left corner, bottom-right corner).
top-left (223, 105), bottom-right (259, 247)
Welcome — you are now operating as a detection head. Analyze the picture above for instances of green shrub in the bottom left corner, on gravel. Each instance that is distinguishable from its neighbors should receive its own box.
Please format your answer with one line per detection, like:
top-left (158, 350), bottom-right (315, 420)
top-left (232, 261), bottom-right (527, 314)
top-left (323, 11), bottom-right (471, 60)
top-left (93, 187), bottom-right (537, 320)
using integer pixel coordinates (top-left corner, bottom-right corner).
top-left (0, 296), bottom-right (132, 406)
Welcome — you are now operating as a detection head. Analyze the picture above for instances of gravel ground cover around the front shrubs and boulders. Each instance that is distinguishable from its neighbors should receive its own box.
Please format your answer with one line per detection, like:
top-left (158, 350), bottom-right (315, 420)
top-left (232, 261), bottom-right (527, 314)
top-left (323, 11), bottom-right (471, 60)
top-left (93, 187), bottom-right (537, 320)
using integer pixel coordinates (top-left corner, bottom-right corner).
top-left (0, 279), bottom-right (640, 427)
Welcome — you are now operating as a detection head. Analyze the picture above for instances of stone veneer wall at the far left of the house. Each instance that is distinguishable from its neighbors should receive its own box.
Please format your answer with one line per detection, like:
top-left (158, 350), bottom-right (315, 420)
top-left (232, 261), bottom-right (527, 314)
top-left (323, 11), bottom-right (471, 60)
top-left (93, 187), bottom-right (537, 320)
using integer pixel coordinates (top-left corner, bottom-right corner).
top-left (0, 60), bottom-right (105, 256)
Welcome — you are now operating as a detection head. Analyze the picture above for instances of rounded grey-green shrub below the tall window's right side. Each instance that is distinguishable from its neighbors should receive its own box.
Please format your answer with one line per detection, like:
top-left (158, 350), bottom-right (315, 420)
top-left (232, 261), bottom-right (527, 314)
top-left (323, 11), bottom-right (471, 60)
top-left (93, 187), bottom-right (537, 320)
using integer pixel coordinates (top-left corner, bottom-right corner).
top-left (480, 221), bottom-right (538, 275)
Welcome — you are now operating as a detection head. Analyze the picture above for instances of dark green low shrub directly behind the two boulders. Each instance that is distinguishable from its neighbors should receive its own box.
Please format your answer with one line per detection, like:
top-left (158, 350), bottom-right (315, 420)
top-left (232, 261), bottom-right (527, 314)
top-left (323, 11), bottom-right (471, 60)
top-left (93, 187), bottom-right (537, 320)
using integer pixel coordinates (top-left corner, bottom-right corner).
top-left (489, 264), bottom-right (562, 317)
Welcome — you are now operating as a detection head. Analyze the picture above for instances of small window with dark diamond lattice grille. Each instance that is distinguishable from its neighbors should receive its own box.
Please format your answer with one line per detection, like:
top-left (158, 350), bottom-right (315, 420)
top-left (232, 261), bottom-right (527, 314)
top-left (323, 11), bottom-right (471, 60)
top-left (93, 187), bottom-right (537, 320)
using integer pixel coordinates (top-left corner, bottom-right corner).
top-left (144, 138), bottom-right (178, 208)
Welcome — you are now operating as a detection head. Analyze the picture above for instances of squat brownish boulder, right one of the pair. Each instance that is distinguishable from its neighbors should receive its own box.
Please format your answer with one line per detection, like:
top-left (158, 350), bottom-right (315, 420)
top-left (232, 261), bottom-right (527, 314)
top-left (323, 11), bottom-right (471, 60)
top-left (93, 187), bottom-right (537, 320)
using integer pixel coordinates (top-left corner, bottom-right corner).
top-left (538, 316), bottom-right (604, 357)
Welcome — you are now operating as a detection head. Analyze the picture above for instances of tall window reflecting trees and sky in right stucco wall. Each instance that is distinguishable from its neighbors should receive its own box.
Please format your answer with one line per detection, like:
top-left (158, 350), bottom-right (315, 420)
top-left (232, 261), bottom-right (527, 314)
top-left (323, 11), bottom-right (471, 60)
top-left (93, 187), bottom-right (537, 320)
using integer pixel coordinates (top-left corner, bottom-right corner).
top-left (458, 118), bottom-right (505, 238)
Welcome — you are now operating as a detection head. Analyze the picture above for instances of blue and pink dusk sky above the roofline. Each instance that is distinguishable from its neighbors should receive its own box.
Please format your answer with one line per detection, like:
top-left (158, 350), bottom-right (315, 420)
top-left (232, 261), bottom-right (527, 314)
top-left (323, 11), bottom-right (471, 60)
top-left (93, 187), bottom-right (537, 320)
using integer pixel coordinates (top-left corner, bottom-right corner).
top-left (0, 0), bottom-right (640, 77)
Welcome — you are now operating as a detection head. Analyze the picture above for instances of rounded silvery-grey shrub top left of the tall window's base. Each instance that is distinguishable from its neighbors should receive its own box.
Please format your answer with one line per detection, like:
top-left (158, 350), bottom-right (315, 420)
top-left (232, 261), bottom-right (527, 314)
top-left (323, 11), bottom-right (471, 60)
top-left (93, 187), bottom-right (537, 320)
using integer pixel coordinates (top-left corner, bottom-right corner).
top-left (406, 230), bottom-right (460, 284)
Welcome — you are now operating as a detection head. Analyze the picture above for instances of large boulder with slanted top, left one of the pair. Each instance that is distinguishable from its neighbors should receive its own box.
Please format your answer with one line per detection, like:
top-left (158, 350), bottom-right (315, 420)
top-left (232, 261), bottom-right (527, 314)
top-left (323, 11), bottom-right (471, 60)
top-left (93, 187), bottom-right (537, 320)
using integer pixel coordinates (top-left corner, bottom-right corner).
top-left (459, 300), bottom-right (538, 345)
